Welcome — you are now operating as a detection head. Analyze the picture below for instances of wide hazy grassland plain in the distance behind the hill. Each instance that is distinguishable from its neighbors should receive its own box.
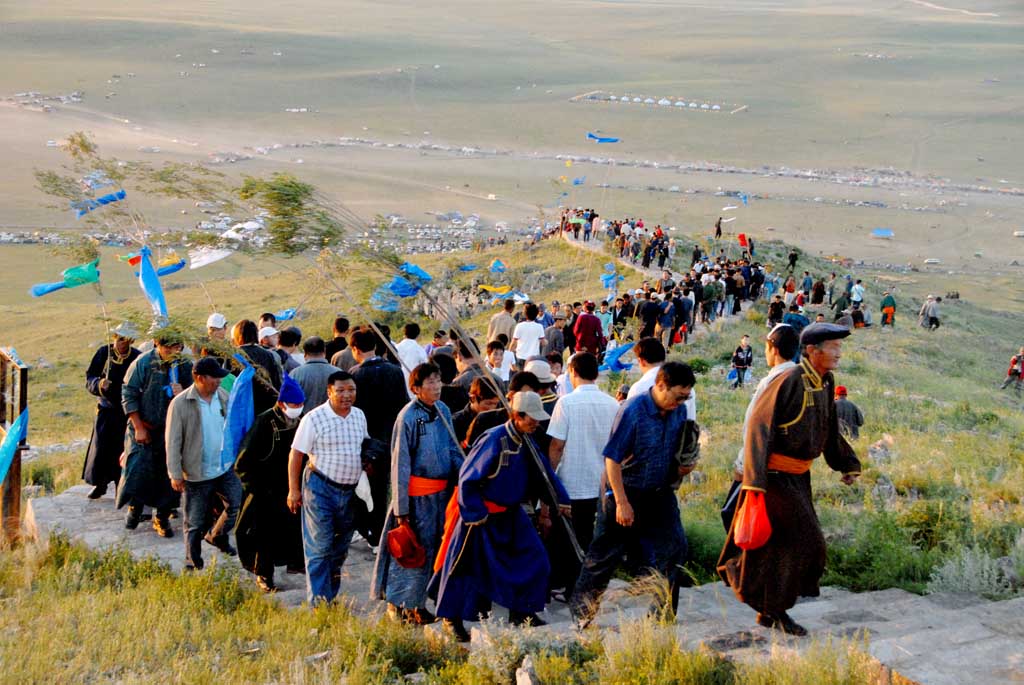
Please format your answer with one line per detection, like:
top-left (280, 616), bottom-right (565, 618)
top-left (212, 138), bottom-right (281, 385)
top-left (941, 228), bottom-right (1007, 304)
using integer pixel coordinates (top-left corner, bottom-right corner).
top-left (0, 0), bottom-right (1024, 277)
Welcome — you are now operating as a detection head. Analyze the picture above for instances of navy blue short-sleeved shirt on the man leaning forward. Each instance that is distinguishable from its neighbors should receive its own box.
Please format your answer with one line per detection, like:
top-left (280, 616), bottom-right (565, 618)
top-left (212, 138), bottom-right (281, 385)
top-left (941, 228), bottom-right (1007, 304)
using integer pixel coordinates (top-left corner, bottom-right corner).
top-left (604, 390), bottom-right (686, 489)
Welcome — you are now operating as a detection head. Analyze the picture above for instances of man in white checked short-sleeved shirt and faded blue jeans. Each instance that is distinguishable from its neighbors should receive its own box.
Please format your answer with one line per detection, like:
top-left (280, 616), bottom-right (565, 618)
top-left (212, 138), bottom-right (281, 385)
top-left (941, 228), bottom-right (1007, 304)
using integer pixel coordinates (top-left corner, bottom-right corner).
top-left (288, 371), bottom-right (370, 605)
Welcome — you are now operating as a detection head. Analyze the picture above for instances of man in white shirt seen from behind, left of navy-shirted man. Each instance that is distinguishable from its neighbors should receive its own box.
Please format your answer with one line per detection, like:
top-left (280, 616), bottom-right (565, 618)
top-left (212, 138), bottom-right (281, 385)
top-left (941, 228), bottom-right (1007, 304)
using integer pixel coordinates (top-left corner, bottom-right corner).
top-left (548, 352), bottom-right (618, 593)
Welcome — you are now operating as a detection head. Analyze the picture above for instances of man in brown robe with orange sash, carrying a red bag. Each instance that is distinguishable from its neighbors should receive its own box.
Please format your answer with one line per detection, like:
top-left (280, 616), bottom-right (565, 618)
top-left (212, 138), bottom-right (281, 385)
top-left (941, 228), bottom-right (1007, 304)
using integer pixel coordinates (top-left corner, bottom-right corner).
top-left (718, 324), bottom-right (860, 635)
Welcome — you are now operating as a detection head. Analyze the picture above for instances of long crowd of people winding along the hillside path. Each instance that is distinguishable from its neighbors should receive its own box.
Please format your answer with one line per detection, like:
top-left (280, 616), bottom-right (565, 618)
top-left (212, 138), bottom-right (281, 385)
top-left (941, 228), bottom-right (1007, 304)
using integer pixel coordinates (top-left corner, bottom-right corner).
top-left (83, 231), bottom-right (983, 640)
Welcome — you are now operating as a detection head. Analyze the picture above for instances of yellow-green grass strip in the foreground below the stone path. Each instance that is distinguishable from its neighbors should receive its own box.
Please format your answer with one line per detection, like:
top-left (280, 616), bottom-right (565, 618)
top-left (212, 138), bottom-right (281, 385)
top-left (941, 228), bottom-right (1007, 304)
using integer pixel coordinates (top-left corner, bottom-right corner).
top-left (0, 537), bottom-right (879, 685)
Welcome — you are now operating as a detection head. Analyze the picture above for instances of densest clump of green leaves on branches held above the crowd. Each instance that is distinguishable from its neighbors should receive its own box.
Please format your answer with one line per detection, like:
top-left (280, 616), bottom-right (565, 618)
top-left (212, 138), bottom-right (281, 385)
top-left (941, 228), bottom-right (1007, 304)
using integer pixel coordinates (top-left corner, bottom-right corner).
top-left (239, 173), bottom-right (342, 255)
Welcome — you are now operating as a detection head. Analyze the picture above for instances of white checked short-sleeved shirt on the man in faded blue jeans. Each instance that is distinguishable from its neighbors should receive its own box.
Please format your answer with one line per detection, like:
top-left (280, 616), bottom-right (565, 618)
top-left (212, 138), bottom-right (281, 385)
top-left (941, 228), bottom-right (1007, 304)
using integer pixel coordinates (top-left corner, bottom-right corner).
top-left (292, 401), bottom-right (370, 485)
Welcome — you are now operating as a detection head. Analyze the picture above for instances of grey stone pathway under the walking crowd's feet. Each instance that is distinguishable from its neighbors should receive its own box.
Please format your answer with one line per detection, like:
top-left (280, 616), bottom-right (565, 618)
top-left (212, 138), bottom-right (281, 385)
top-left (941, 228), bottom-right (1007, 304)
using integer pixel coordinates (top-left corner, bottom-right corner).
top-left (25, 485), bottom-right (1024, 685)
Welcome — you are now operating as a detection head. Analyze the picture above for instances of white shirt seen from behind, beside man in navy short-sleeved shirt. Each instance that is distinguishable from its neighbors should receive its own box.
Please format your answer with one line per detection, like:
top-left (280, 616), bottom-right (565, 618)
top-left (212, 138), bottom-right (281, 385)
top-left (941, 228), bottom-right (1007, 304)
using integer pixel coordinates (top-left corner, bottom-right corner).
top-left (548, 383), bottom-right (618, 500)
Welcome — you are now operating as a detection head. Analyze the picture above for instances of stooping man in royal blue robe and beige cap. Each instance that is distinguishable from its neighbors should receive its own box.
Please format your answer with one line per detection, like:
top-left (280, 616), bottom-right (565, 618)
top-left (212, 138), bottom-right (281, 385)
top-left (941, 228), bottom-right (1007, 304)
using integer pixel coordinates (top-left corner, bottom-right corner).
top-left (431, 392), bottom-right (569, 641)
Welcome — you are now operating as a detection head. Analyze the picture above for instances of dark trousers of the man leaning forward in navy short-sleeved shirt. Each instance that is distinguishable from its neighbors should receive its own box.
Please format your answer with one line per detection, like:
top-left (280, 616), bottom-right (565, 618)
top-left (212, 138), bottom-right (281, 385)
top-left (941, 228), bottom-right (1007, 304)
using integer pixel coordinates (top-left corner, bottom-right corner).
top-left (569, 487), bottom-right (687, 619)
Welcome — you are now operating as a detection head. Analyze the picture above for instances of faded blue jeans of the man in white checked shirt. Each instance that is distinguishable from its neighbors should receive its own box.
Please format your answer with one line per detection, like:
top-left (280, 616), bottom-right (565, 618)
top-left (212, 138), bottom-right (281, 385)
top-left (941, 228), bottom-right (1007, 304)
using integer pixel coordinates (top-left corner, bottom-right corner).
top-left (302, 466), bottom-right (356, 605)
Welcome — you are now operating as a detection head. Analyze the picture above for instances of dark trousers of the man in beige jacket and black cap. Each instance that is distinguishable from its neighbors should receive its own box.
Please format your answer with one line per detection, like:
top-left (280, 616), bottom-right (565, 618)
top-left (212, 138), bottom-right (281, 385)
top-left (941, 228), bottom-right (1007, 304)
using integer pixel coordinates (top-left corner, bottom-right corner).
top-left (185, 470), bottom-right (242, 568)
